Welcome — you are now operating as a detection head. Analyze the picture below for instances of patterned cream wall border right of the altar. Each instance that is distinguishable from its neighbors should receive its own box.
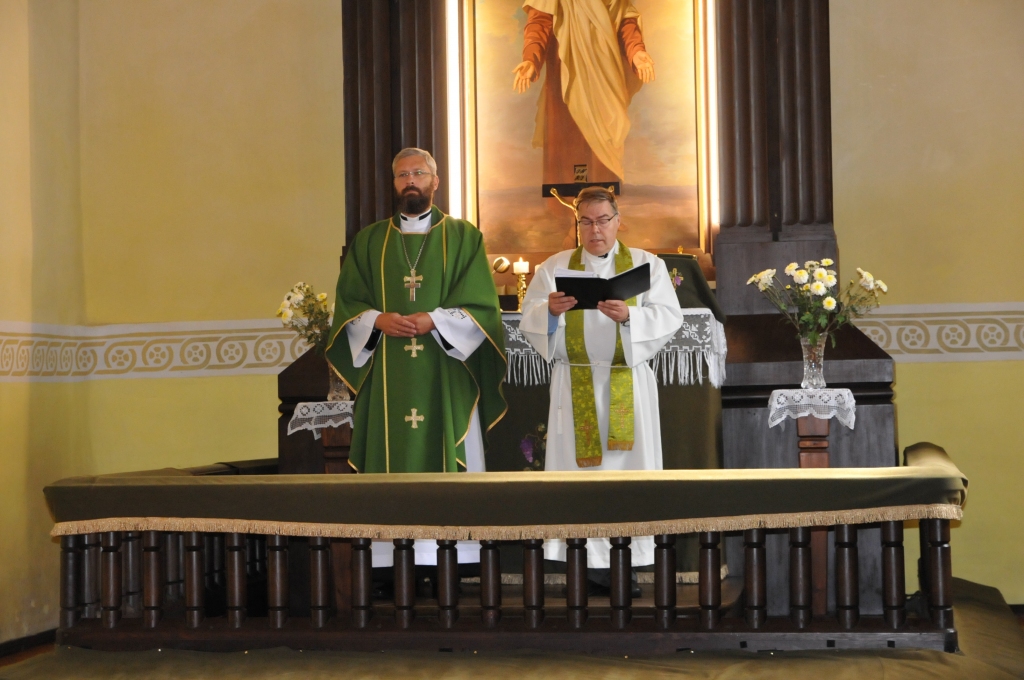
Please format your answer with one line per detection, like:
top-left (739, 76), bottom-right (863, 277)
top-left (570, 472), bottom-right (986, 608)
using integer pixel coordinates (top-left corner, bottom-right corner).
top-left (855, 302), bottom-right (1024, 364)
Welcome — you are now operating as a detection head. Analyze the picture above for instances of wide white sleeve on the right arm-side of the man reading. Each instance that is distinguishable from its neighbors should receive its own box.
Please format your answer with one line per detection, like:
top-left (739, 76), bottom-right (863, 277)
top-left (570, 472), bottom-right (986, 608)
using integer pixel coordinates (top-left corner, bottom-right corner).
top-left (621, 257), bottom-right (683, 366)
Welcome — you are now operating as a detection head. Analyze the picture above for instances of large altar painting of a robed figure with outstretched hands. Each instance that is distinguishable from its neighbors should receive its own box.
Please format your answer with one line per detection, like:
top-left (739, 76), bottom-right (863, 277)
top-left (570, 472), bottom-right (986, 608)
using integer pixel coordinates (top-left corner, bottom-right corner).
top-left (452, 0), bottom-right (711, 280)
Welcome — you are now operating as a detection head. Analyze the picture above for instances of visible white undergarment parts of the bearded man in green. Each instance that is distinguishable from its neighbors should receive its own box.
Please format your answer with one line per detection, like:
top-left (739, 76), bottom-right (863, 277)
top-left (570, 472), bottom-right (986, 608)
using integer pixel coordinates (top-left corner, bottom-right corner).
top-left (345, 210), bottom-right (486, 566)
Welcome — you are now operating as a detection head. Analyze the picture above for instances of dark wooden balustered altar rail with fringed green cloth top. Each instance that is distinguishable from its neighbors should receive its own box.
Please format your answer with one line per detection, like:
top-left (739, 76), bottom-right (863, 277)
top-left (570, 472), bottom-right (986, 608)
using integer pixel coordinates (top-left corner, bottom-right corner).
top-left (45, 447), bottom-right (967, 653)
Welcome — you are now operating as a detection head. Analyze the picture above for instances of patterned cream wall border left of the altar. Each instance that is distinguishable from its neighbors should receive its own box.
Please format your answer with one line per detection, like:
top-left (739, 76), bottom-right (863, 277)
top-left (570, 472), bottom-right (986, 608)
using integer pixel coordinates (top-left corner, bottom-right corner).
top-left (0, 318), bottom-right (309, 382)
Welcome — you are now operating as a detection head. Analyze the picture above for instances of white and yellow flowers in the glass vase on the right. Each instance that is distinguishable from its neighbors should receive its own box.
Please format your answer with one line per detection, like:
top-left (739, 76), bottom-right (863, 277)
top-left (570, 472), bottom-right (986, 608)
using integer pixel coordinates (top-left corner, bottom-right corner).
top-left (746, 258), bottom-right (889, 347)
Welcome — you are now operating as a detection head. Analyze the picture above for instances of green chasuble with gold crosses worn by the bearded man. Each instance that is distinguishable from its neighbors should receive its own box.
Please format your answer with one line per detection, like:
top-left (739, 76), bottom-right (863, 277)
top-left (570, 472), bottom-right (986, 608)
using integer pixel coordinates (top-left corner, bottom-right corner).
top-left (327, 207), bottom-right (506, 472)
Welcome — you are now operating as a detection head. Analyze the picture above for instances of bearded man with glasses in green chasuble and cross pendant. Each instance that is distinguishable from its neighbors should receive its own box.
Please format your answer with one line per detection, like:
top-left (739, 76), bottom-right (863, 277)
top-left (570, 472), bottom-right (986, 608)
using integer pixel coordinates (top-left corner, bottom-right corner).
top-left (327, 148), bottom-right (506, 472)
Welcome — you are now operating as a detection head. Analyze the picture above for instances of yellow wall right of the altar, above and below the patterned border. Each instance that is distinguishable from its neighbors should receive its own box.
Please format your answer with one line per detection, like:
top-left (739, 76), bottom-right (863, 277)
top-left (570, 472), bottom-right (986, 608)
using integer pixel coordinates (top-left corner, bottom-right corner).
top-left (830, 0), bottom-right (1024, 603)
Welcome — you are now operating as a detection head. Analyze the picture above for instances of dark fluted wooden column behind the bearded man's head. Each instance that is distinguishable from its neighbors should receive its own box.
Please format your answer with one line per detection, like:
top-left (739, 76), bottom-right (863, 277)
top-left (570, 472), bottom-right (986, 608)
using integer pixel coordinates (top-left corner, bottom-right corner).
top-left (341, 0), bottom-right (447, 243)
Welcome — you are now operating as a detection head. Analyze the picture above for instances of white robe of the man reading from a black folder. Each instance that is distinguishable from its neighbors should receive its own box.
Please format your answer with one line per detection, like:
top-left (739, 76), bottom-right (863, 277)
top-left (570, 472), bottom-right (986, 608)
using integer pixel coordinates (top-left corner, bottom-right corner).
top-left (519, 244), bottom-right (683, 568)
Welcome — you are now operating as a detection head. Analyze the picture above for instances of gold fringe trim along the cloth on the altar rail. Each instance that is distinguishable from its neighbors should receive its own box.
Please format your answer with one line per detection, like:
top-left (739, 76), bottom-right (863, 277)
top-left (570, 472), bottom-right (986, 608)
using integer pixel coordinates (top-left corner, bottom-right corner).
top-left (50, 504), bottom-right (964, 541)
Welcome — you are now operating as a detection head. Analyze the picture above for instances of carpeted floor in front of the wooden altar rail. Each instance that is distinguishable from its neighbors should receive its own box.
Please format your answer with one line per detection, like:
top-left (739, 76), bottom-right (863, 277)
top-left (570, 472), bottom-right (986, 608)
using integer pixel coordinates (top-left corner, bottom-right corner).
top-left (0, 580), bottom-right (1024, 680)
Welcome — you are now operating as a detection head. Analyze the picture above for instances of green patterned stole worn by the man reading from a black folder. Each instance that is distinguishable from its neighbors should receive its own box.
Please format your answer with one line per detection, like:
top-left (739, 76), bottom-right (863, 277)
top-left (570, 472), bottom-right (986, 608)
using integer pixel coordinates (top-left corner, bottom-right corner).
top-left (565, 241), bottom-right (637, 467)
